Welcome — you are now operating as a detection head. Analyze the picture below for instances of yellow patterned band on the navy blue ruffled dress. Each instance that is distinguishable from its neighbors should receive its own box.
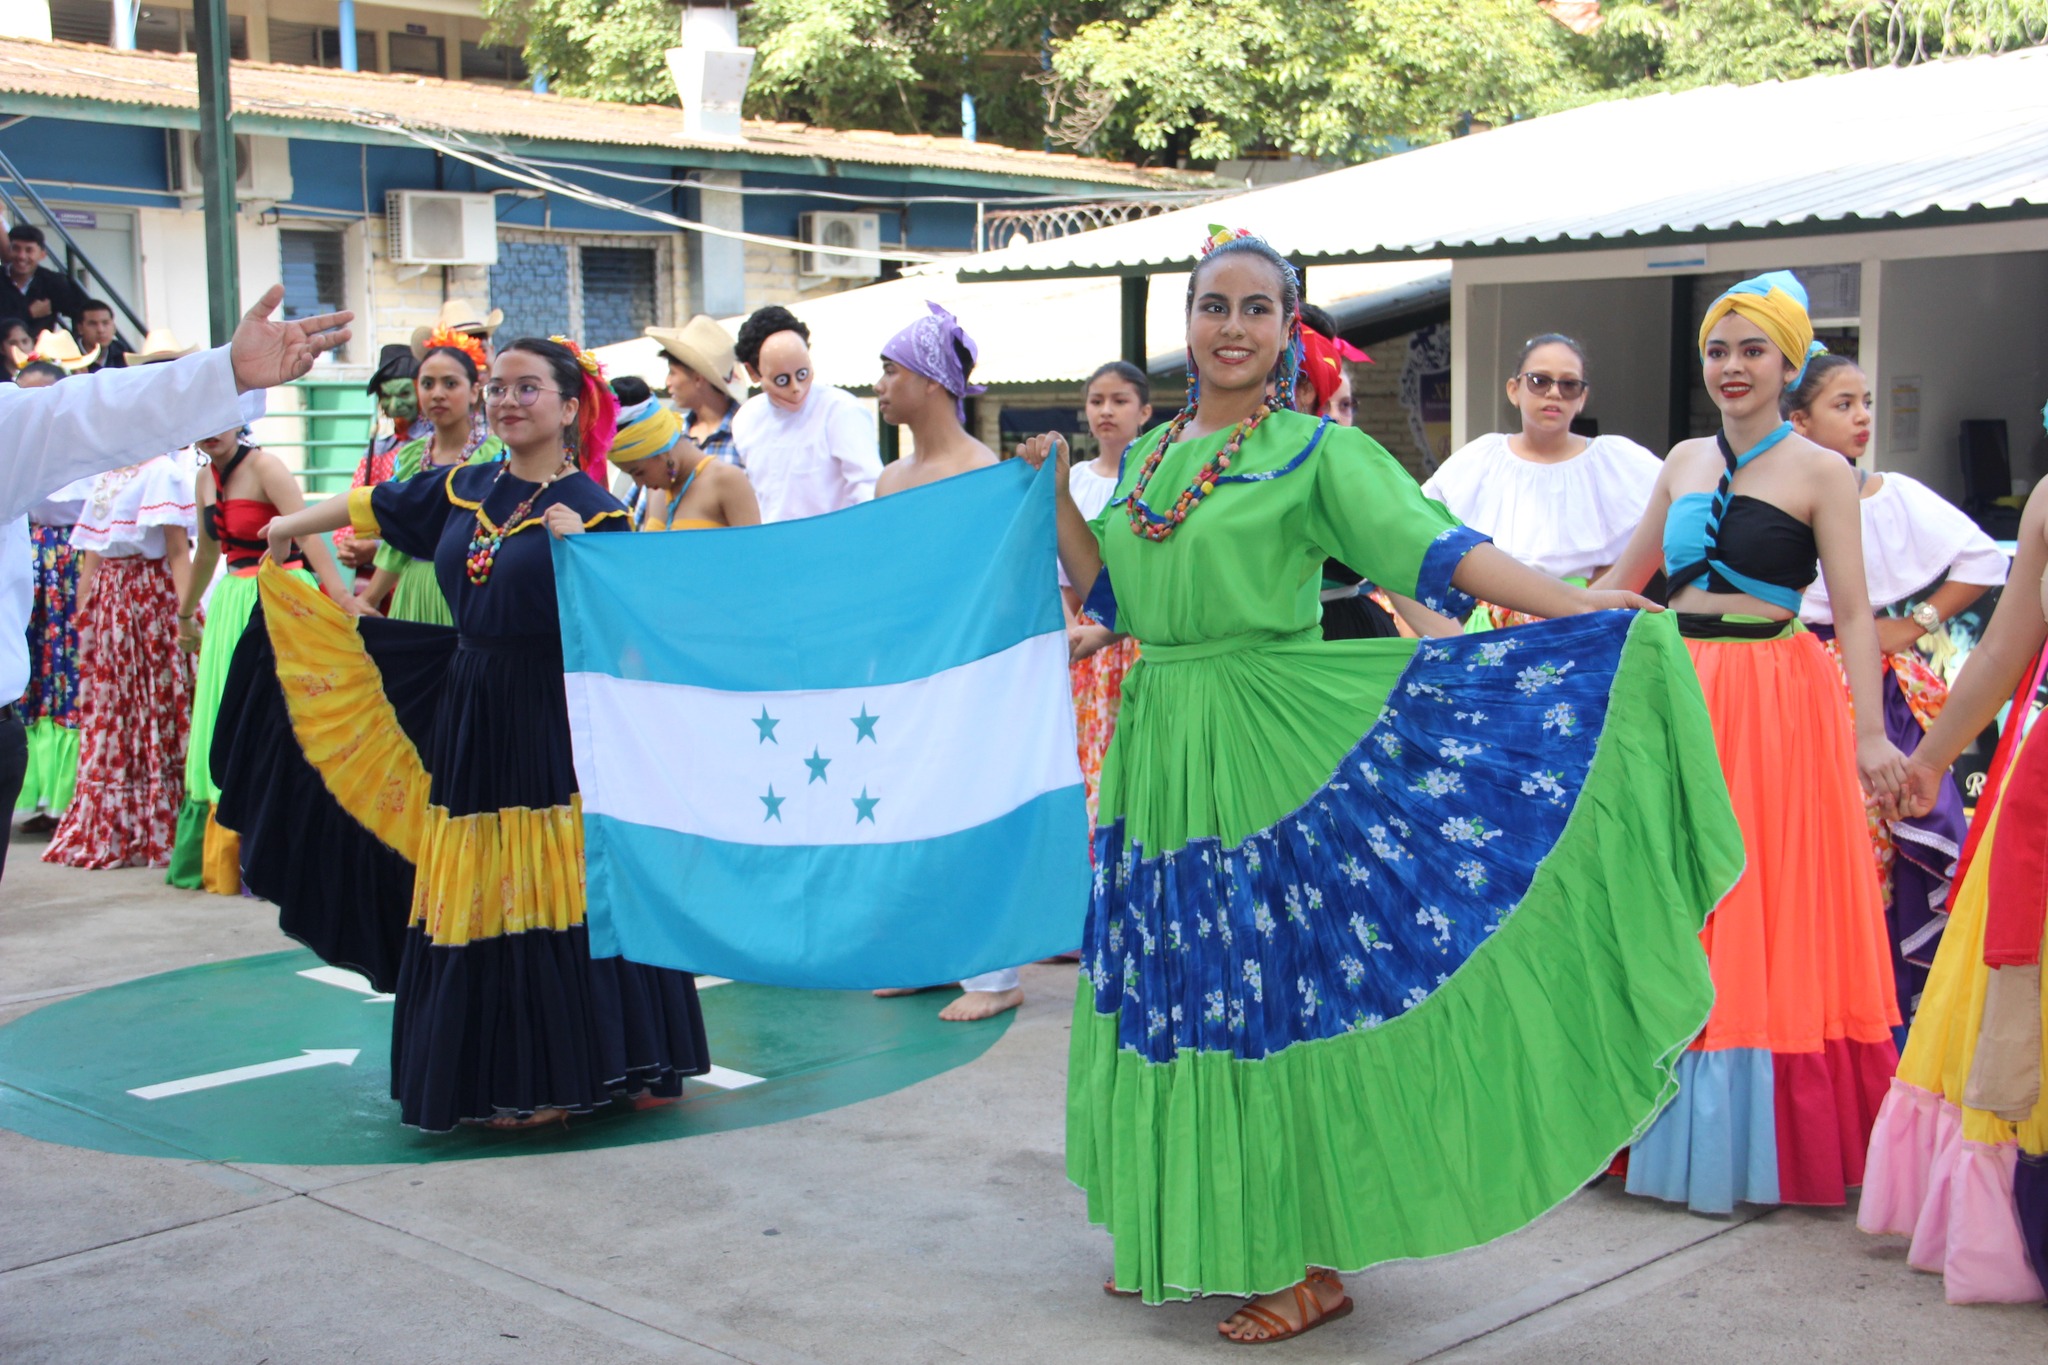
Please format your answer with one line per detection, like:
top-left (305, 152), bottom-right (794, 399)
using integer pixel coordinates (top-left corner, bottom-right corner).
top-left (256, 561), bottom-right (586, 948)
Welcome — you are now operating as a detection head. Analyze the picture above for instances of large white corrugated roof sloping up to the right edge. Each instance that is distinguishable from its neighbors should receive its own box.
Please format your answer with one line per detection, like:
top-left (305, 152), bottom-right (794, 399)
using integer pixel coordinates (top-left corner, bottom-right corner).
top-left (961, 49), bottom-right (2048, 280)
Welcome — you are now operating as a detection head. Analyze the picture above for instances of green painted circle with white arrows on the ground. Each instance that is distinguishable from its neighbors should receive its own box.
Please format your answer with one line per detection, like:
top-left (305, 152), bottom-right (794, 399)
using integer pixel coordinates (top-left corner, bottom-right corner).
top-left (0, 950), bottom-right (1012, 1166)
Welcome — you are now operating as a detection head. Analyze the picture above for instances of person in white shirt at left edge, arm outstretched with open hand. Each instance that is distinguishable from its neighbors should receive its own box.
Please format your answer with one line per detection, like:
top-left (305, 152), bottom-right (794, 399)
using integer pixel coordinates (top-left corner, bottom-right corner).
top-left (0, 287), bottom-right (352, 888)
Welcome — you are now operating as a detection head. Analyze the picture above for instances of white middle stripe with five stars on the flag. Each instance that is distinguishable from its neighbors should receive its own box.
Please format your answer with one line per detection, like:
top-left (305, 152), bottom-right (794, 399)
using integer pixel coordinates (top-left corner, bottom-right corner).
top-left (567, 630), bottom-right (1081, 847)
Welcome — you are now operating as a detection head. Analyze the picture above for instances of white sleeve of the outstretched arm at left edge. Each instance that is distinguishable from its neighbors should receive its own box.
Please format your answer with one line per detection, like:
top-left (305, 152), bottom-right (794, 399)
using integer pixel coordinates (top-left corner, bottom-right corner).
top-left (0, 346), bottom-right (242, 522)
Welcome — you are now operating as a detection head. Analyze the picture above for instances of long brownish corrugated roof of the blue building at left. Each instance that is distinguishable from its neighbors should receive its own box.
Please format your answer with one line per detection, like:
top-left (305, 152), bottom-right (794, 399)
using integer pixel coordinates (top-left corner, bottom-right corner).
top-left (0, 39), bottom-right (1206, 190)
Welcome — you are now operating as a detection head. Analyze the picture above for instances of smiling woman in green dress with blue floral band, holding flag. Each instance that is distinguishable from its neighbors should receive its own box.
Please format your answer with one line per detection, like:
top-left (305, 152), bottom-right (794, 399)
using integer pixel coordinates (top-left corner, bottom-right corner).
top-left (1020, 229), bottom-right (1743, 1342)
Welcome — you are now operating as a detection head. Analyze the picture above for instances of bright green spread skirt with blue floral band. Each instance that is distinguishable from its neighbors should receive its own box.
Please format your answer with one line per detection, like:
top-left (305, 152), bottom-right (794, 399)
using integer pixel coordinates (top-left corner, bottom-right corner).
top-left (1067, 612), bottom-right (1743, 1302)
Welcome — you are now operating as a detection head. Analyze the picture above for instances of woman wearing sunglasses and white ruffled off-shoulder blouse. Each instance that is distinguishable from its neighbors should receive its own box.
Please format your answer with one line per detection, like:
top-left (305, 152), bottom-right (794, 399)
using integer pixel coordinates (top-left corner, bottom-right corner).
top-left (1421, 332), bottom-right (1663, 630)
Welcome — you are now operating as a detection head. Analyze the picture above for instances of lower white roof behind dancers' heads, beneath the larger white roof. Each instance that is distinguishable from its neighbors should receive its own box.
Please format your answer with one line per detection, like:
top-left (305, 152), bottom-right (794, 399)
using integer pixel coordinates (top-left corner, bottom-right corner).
top-left (598, 260), bottom-right (1450, 395)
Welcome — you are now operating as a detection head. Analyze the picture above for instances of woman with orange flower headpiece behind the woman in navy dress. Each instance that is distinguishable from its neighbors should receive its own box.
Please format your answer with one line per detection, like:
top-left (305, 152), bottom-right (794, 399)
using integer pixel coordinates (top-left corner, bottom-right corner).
top-left (360, 327), bottom-right (506, 626)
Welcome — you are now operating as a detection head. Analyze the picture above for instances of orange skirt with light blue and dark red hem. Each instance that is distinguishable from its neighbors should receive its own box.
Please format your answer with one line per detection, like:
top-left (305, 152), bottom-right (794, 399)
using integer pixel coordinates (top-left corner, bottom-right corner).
top-left (1628, 628), bottom-right (1898, 1212)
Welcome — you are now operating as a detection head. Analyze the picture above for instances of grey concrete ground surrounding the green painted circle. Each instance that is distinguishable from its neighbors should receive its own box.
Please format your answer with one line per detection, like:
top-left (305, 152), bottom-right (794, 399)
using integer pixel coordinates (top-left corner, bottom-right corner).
top-left (0, 835), bottom-right (2048, 1365)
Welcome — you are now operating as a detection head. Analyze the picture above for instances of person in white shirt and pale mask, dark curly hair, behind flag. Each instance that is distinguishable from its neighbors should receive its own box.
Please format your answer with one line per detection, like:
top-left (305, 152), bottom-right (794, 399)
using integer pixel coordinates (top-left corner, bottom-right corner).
top-left (733, 305), bottom-right (883, 522)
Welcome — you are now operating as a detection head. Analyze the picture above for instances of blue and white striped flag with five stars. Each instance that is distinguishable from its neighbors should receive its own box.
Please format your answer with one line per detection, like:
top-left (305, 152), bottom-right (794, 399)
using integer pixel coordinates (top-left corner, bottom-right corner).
top-left (555, 460), bottom-right (1087, 986)
